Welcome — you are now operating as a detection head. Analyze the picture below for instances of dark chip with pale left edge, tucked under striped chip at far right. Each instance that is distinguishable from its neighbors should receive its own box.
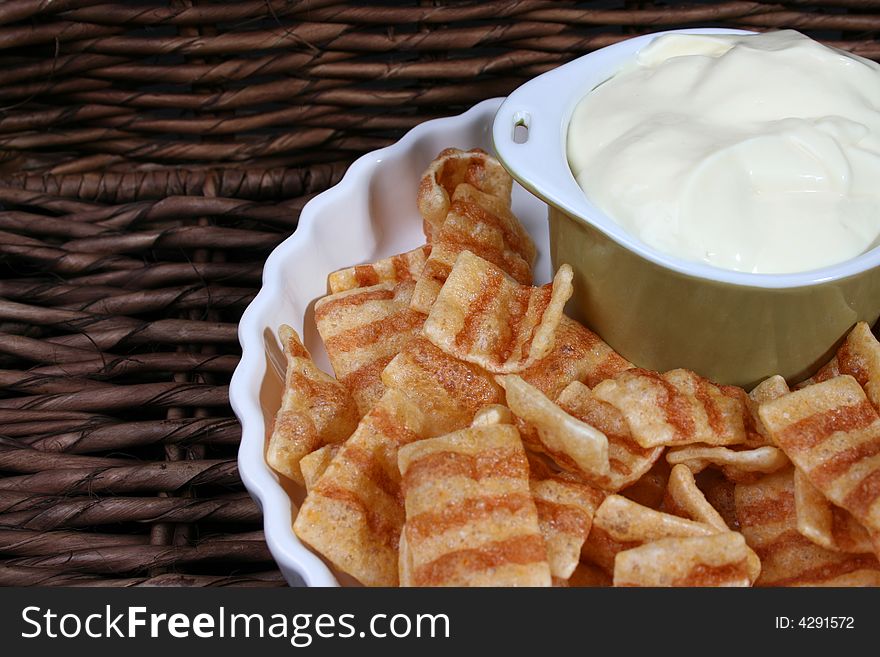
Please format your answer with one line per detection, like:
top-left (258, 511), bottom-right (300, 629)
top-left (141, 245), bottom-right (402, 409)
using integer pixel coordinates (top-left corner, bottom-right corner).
top-left (794, 470), bottom-right (874, 554)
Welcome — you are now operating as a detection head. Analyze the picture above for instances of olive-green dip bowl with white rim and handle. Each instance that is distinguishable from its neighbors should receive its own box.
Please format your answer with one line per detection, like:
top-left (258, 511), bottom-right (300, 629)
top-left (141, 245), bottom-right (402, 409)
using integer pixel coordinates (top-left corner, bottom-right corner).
top-left (493, 29), bottom-right (880, 388)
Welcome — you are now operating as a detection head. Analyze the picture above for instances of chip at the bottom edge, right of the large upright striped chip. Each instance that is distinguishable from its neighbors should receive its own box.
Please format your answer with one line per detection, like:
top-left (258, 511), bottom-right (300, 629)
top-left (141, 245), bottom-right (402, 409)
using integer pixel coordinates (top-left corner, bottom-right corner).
top-left (614, 532), bottom-right (753, 586)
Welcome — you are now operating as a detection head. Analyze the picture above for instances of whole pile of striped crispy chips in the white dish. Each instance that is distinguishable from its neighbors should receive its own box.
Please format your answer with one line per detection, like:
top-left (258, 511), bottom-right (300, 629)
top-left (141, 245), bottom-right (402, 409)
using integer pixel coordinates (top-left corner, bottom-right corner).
top-left (267, 149), bottom-right (880, 586)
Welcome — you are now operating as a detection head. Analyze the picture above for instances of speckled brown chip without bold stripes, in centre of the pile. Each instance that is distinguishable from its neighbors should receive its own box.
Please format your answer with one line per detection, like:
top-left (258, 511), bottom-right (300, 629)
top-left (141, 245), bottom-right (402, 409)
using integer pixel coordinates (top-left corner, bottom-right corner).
top-left (382, 336), bottom-right (504, 437)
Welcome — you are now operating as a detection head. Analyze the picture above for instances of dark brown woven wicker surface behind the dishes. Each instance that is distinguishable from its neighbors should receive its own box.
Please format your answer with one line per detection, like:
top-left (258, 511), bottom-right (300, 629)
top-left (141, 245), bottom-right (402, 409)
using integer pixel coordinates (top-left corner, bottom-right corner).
top-left (0, 0), bottom-right (880, 586)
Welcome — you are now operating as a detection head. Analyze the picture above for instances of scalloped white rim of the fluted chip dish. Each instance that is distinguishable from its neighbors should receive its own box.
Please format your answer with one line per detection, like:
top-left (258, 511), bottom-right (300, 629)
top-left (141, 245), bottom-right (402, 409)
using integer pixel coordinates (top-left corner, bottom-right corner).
top-left (229, 98), bottom-right (503, 586)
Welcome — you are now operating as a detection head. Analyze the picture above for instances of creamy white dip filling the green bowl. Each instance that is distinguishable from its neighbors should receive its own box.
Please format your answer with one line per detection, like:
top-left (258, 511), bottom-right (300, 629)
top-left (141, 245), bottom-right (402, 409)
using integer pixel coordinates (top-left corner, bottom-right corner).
top-left (567, 30), bottom-right (880, 273)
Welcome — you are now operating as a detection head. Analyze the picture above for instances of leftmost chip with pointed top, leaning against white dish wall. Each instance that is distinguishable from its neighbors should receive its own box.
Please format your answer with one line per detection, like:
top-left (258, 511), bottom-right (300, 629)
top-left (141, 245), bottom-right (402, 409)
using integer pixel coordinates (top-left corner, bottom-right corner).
top-left (266, 325), bottom-right (359, 484)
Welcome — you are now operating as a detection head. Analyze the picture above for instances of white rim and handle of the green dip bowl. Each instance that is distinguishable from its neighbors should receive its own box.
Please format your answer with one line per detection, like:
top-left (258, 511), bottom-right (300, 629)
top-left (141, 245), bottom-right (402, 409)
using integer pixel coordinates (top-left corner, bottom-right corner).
top-left (492, 28), bottom-right (880, 289)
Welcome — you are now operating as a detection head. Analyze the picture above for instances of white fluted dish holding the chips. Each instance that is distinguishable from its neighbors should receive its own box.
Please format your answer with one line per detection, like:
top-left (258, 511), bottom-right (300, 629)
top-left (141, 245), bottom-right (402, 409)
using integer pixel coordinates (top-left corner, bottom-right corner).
top-left (229, 98), bottom-right (551, 586)
